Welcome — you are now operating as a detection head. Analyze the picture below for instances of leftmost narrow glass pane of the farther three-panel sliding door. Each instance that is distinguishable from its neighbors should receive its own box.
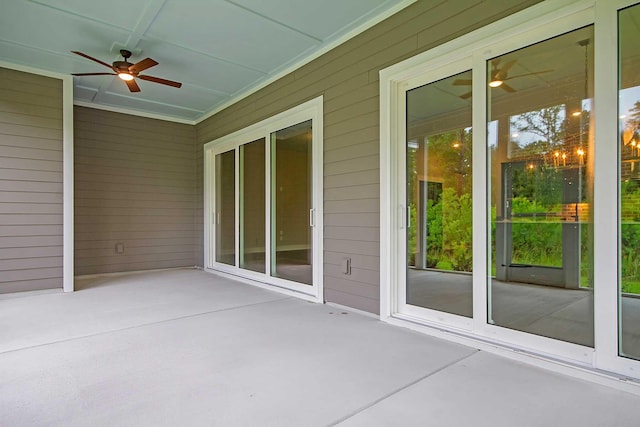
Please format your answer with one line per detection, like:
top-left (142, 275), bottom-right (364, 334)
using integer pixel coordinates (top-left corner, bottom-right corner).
top-left (215, 150), bottom-right (236, 265)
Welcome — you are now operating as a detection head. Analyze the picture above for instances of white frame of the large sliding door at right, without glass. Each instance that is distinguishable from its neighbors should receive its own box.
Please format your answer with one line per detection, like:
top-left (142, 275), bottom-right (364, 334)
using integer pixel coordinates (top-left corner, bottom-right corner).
top-left (380, 0), bottom-right (640, 378)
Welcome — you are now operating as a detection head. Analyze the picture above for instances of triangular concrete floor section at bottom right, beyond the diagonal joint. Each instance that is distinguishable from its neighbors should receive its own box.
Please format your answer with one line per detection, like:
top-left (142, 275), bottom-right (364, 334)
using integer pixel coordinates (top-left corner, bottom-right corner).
top-left (340, 352), bottom-right (640, 427)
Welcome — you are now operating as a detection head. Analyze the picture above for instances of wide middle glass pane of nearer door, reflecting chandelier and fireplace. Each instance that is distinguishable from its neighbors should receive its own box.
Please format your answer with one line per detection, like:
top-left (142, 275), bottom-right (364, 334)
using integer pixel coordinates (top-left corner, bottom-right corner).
top-left (487, 26), bottom-right (594, 347)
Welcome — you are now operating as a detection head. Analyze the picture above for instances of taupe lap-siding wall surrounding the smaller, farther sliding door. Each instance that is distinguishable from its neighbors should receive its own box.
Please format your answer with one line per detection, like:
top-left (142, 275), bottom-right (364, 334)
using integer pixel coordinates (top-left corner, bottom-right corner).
top-left (197, 0), bottom-right (538, 313)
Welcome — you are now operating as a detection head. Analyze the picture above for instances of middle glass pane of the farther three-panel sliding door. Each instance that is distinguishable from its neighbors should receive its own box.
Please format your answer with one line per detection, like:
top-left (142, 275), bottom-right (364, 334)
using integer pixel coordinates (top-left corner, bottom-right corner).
top-left (240, 139), bottom-right (266, 273)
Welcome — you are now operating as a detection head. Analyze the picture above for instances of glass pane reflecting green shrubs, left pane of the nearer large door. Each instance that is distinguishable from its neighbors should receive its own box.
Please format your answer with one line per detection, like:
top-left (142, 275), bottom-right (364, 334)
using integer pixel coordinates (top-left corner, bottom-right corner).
top-left (406, 71), bottom-right (473, 317)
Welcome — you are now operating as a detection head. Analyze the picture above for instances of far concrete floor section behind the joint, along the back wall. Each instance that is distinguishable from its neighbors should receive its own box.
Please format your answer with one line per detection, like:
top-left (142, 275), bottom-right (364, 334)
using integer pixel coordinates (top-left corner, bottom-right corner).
top-left (0, 269), bottom-right (288, 352)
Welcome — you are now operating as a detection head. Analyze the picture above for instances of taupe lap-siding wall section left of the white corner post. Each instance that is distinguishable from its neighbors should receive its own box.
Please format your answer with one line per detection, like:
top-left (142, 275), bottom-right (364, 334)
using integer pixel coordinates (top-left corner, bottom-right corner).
top-left (0, 68), bottom-right (63, 293)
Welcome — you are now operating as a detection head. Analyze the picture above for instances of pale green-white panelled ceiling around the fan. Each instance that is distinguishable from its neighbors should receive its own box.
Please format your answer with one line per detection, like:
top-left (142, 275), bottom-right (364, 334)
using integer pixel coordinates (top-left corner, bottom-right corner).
top-left (0, 0), bottom-right (415, 123)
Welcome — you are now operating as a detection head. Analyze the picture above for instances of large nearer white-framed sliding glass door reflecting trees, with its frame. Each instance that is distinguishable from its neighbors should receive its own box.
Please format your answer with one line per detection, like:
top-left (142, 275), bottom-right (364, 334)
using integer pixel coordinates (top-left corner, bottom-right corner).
top-left (380, 0), bottom-right (640, 378)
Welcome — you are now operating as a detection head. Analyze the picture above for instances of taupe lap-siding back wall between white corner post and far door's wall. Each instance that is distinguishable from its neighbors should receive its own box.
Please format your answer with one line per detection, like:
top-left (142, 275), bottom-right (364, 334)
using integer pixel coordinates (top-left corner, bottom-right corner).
top-left (74, 107), bottom-right (197, 275)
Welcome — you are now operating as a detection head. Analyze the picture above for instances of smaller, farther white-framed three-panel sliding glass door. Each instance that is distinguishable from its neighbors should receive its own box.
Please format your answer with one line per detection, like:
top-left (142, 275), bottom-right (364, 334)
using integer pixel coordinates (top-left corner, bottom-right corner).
top-left (205, 98), bottom-right (322, 298)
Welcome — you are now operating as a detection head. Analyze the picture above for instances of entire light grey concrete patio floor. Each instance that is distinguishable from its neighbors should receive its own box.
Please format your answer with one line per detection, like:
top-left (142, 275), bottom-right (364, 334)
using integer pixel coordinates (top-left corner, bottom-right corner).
top-left (0, 269), bottom-right (640, 427)
